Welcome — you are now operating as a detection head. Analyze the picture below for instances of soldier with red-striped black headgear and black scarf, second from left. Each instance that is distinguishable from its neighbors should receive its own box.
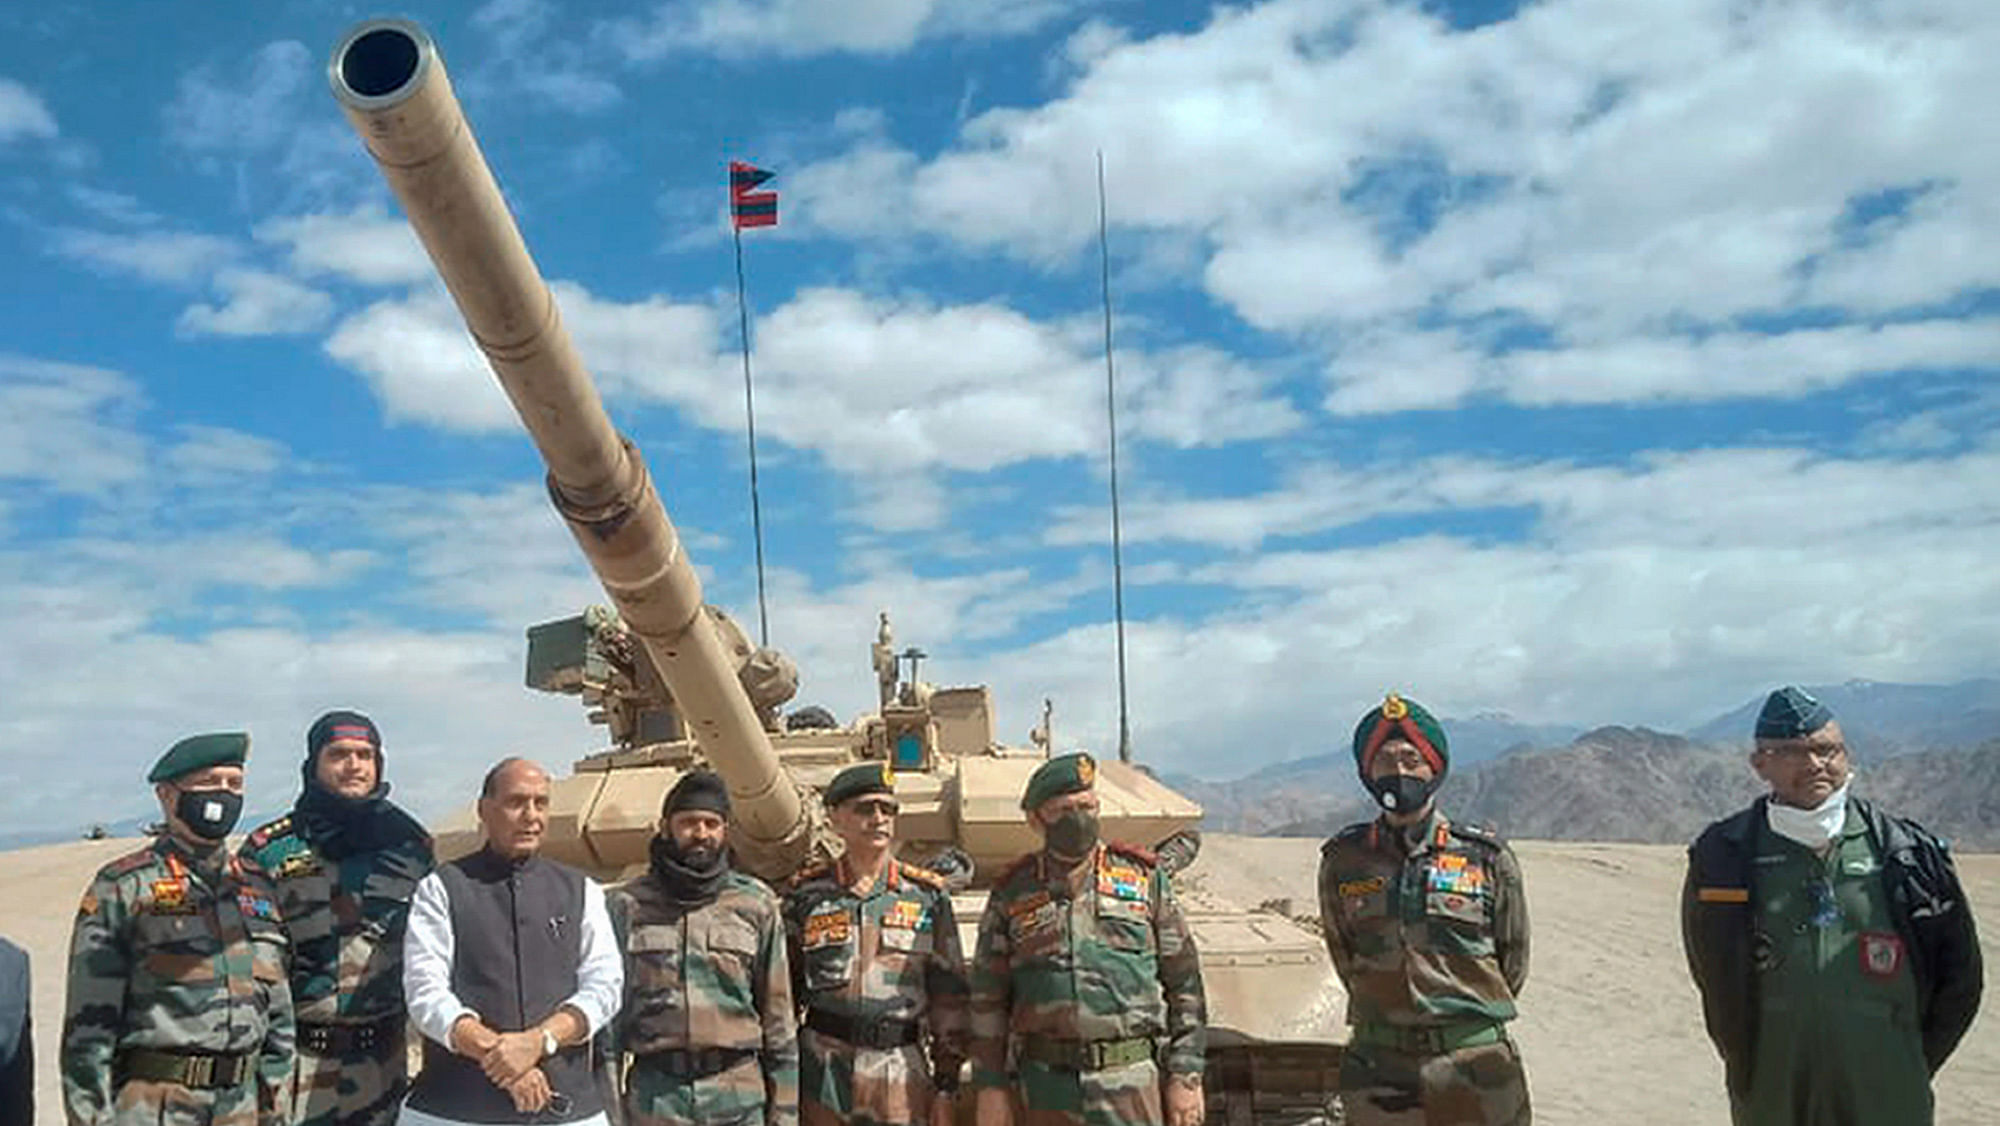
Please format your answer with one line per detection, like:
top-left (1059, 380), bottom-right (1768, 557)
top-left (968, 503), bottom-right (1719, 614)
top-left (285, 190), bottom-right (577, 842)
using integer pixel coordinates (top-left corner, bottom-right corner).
top-left (242, 712), bottom-right (436, 1126)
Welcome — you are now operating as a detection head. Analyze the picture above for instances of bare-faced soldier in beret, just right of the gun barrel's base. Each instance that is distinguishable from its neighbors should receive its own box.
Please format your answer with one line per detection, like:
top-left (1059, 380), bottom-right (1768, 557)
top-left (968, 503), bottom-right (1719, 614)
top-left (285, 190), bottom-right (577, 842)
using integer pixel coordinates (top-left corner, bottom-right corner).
top-left (784, 762), bottom-right (966, 1126)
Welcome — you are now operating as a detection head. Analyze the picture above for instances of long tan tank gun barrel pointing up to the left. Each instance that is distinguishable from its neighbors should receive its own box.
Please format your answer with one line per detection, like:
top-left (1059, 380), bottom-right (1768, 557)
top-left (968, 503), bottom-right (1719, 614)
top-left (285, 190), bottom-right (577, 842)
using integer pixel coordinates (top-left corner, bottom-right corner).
top-left (328, 20), bottom-right (810, 874)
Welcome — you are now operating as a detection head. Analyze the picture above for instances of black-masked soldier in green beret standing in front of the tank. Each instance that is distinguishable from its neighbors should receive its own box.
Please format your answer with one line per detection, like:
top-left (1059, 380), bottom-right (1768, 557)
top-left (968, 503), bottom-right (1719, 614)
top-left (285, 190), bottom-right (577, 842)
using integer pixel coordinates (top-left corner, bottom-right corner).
top-left (972, 754), bottom-right (1208, 1126)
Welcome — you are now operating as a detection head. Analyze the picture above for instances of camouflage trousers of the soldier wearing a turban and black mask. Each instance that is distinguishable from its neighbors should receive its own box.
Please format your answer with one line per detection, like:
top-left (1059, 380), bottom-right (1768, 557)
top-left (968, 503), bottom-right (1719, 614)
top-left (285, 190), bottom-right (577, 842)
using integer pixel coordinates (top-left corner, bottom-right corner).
top-left (1340, 1040), bottom-right (1534, 1126)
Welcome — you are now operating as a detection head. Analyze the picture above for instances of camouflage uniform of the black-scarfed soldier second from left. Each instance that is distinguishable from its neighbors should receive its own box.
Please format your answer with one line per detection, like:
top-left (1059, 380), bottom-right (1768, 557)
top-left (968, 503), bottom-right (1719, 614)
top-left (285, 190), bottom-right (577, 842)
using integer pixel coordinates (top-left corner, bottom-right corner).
top-left (242, 818), bottom-right (436, 1126)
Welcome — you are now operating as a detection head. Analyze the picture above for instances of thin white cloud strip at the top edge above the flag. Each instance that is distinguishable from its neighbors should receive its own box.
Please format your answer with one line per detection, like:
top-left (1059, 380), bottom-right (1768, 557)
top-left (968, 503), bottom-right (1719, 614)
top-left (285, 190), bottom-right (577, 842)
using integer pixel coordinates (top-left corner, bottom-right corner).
top-left (608, 0), bottom-right (1080, 60)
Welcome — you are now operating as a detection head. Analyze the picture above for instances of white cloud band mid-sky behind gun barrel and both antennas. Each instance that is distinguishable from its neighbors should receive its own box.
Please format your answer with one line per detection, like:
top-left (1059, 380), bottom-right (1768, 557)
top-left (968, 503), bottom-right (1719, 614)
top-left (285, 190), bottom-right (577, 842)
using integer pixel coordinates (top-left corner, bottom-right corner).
top-left (326, 284), bottom-right (1300, 484)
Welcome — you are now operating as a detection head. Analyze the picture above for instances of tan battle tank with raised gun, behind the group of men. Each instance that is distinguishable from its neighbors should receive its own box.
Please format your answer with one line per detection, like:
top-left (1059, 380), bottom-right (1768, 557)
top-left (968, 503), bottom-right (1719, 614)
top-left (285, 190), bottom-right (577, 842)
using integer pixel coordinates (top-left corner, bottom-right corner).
top-left (328, 20), bottom-right (1342, 1126)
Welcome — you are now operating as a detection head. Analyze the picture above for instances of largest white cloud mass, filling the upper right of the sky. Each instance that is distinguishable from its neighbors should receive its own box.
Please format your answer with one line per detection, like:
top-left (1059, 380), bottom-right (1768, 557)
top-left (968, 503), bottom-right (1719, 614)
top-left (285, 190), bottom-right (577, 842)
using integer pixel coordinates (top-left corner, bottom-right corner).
top-left (790, 0), bottom-right (2000, 412)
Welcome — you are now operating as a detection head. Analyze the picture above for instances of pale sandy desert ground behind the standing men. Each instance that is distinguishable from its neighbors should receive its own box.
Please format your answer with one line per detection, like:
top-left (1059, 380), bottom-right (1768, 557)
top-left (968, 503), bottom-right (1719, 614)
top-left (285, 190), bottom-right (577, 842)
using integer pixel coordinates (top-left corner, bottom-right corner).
top-left (0, 834), bottom-right (2000, 1126)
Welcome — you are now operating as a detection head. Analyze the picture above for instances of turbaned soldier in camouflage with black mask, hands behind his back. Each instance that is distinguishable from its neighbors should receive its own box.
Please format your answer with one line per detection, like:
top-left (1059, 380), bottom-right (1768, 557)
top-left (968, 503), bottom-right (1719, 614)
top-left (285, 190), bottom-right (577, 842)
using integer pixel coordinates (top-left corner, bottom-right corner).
top-left (1320, 694), bottom-right (1532, 1126)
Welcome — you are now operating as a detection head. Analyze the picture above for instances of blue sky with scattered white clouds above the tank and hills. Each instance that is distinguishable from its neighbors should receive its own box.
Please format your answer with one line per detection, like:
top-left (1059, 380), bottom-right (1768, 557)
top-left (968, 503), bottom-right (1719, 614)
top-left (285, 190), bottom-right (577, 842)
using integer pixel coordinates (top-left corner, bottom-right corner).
top-left (0, 0), bottom-right (2000, 830)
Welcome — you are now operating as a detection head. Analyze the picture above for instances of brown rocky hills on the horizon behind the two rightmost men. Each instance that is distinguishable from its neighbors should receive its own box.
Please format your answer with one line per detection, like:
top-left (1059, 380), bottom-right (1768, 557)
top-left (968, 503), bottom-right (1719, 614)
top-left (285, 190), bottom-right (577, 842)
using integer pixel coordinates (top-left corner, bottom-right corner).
top-left (1270, 728), bottom-right (2000, 852)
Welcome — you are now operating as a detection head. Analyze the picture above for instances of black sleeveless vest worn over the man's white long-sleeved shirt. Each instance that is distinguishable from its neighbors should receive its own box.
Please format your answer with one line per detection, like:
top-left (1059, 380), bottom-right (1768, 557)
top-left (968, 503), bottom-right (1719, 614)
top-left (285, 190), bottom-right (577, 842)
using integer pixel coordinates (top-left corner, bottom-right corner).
top-left (410, 848), bottom-right (604, 1122)
